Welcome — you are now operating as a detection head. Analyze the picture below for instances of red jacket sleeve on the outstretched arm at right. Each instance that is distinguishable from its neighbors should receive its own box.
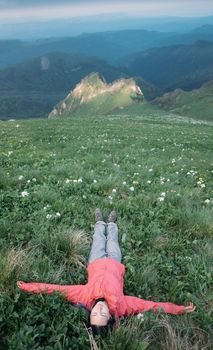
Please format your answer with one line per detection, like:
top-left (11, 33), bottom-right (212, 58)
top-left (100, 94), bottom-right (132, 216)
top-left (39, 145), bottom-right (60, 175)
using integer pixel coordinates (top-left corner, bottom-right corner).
top-left (125, 296), bottom-right (184, 315)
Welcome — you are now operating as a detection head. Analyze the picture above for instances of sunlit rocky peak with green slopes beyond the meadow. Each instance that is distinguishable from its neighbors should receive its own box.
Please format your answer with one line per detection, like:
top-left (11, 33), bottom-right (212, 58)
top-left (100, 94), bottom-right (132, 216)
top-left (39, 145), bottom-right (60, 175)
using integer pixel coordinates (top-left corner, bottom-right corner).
top-left (49, 73), bottom-right (145, 118)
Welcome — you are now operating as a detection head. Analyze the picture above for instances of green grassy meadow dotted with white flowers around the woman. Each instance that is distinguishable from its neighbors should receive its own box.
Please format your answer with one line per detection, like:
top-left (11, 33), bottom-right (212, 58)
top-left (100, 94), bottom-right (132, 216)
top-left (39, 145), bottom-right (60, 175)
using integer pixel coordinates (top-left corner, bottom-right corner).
top-left (0, 111), bottom-right (213, 350)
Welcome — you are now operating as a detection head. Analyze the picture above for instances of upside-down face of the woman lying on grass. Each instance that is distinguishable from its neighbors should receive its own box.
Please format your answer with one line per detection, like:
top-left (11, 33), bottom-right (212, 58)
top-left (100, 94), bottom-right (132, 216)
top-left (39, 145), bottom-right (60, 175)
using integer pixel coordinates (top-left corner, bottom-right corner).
top-left (90, 301), bottom-right (111, 326)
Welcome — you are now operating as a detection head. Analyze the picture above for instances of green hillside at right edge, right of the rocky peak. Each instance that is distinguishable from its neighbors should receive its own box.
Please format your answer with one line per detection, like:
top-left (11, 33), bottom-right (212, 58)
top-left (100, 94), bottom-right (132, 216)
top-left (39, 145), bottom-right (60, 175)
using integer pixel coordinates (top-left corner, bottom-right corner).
top-left (153, 81), bottom-right (213, 121)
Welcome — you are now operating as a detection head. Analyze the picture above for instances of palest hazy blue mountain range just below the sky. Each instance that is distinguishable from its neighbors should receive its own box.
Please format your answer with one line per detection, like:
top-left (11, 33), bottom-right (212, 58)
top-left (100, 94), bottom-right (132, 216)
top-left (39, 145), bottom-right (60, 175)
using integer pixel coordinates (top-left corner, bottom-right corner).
top-left (0, 13), bottom-right (213, 40)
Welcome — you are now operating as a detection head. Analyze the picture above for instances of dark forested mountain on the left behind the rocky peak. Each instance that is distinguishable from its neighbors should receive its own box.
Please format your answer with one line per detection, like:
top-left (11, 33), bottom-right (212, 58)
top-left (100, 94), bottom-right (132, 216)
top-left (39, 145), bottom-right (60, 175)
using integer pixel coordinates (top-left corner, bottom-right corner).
top-left (0, 53), bottom-right (124, 119)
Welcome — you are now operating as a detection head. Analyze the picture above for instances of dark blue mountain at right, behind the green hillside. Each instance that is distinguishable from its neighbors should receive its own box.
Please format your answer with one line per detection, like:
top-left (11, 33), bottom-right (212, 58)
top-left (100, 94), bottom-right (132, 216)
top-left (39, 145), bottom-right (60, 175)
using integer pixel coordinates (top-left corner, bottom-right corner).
top-left (123, 41), bottom-right (213, 91)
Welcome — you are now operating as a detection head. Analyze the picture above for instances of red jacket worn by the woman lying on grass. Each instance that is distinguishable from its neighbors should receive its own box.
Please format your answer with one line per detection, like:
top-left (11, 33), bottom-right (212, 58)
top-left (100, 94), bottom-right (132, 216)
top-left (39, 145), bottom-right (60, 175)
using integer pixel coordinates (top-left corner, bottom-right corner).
top-left (19, 258), bottom-right (184, 317)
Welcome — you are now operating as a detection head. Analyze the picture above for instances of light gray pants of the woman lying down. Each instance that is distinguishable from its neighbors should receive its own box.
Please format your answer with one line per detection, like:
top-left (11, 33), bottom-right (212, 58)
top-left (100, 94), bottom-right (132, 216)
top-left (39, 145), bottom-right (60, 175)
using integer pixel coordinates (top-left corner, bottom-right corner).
top-left (88, 221), bottom-right (121, 264)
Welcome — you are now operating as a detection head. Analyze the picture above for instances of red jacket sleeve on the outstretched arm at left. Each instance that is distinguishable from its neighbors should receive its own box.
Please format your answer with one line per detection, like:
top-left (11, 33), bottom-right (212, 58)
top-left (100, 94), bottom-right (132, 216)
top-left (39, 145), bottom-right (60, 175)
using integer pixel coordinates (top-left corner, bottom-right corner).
top-left (17, 282), bottom-right (84, 303)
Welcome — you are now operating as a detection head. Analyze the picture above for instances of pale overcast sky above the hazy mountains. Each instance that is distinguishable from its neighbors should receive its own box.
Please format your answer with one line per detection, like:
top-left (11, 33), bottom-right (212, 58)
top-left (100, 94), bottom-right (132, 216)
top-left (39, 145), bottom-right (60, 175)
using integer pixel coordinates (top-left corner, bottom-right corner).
top-left (0, 0), bottom-right (213, 22)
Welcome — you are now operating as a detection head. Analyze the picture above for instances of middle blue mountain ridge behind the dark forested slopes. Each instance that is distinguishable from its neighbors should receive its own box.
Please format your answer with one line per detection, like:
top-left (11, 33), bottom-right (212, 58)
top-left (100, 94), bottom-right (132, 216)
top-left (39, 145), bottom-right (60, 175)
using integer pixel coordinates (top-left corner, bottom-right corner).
top-left (0, 25), bottom-right (213, 68)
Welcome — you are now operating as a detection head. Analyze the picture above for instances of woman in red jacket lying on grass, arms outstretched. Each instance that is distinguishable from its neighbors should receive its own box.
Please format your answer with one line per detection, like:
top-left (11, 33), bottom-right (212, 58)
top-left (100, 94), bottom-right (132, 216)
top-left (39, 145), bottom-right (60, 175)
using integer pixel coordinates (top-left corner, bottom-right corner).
top-left (17, 209), bottom-right (195, 331)
